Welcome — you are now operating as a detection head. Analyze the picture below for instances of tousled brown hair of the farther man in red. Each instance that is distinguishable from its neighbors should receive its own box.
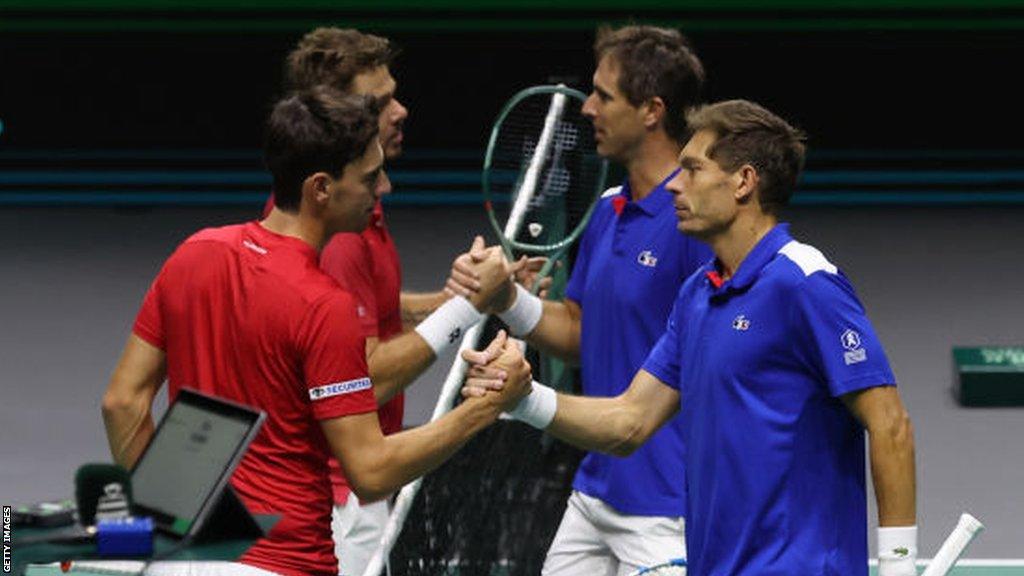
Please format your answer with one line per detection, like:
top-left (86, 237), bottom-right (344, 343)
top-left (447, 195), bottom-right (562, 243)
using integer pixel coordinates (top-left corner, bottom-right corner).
top-left (285, 28), bottom-right (397, 92)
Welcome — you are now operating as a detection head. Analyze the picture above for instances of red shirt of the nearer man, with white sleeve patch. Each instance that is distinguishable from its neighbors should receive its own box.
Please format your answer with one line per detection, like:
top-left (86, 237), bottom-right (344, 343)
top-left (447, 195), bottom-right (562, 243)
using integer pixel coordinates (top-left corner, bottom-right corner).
top-left (134, 222), bottom-right (377, 575)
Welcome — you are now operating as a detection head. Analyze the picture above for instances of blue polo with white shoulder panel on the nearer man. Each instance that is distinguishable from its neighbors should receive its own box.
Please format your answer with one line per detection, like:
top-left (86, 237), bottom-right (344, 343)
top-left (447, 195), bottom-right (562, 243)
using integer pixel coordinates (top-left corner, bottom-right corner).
top-left (644, 224), bottom-right (896, 576)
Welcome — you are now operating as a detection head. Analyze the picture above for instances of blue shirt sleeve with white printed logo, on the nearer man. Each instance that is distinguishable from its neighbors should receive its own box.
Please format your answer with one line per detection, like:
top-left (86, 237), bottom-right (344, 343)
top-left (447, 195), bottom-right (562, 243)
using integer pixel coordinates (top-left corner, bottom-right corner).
top-left (793, 272), bottom-right (896, 397)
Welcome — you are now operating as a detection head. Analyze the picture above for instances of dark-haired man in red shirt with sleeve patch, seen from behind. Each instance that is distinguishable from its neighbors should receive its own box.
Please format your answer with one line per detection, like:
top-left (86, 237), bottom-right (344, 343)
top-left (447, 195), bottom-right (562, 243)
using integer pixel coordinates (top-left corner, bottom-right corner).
top-left (102, 88), bottom-right (525, 576)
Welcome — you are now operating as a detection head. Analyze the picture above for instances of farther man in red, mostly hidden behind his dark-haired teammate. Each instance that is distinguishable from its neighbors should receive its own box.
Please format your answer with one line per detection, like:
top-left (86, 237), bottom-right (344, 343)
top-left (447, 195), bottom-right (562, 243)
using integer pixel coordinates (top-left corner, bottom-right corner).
top-left (285, 28), bottom-right (528, 576)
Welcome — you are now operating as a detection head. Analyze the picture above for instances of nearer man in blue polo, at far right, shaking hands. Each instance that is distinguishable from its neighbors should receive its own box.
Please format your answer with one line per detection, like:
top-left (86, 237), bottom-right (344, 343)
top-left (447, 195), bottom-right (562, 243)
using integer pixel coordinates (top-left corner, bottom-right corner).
top-left (464, 100), bottom-right (916, 576)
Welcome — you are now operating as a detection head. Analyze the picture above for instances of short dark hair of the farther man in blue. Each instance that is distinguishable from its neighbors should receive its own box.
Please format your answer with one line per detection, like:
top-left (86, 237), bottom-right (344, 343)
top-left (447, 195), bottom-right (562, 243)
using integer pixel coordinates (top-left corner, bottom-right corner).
top-left (594, 26), bottom-right (705, 141)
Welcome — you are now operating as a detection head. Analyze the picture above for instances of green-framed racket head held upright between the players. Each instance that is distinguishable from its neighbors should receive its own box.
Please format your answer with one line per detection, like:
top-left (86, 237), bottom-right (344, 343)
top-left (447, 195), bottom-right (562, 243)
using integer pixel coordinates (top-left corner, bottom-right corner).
top-left (481, 85), bottom-right (608, 256)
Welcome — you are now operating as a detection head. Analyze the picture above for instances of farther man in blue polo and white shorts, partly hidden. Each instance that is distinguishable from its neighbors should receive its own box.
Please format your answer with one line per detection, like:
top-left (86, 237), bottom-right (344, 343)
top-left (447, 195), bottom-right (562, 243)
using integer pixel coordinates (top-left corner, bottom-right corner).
top-left (448, 26), bottom-right (711, 576)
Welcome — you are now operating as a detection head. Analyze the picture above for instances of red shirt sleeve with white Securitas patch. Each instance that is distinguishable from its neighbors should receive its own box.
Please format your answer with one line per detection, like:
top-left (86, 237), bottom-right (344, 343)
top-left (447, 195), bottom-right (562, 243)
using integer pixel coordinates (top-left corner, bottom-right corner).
top-left (299, 290), bottom-right (377, 420)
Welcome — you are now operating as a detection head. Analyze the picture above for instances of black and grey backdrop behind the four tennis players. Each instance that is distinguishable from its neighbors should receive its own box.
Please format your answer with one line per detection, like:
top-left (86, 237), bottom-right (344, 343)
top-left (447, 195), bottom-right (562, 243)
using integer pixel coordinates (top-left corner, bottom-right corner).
top-left (0, 0), bottom-right (1024, 558)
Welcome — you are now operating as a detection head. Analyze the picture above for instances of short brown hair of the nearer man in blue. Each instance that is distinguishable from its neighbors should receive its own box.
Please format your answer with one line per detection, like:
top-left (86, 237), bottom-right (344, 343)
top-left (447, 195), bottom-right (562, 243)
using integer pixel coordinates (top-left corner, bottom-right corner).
top-left (686, 100), bottom-right (807, 213)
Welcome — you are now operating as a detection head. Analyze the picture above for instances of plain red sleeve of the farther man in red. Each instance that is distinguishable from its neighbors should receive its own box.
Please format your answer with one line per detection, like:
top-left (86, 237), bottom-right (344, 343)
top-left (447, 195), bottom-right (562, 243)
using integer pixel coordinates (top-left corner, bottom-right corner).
top-left (321, 233), bottom-right (380, 338)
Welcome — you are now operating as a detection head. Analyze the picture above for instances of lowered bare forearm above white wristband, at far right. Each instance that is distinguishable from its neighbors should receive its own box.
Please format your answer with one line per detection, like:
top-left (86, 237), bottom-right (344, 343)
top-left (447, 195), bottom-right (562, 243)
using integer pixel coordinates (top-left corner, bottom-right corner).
top-left (868, 413), bottom-right (916, 526)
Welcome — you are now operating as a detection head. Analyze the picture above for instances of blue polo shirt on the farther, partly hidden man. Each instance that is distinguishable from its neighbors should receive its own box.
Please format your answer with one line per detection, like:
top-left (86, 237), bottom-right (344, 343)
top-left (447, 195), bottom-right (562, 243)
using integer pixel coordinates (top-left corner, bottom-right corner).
top-left (565, 173), bottom-right (712, 517)
